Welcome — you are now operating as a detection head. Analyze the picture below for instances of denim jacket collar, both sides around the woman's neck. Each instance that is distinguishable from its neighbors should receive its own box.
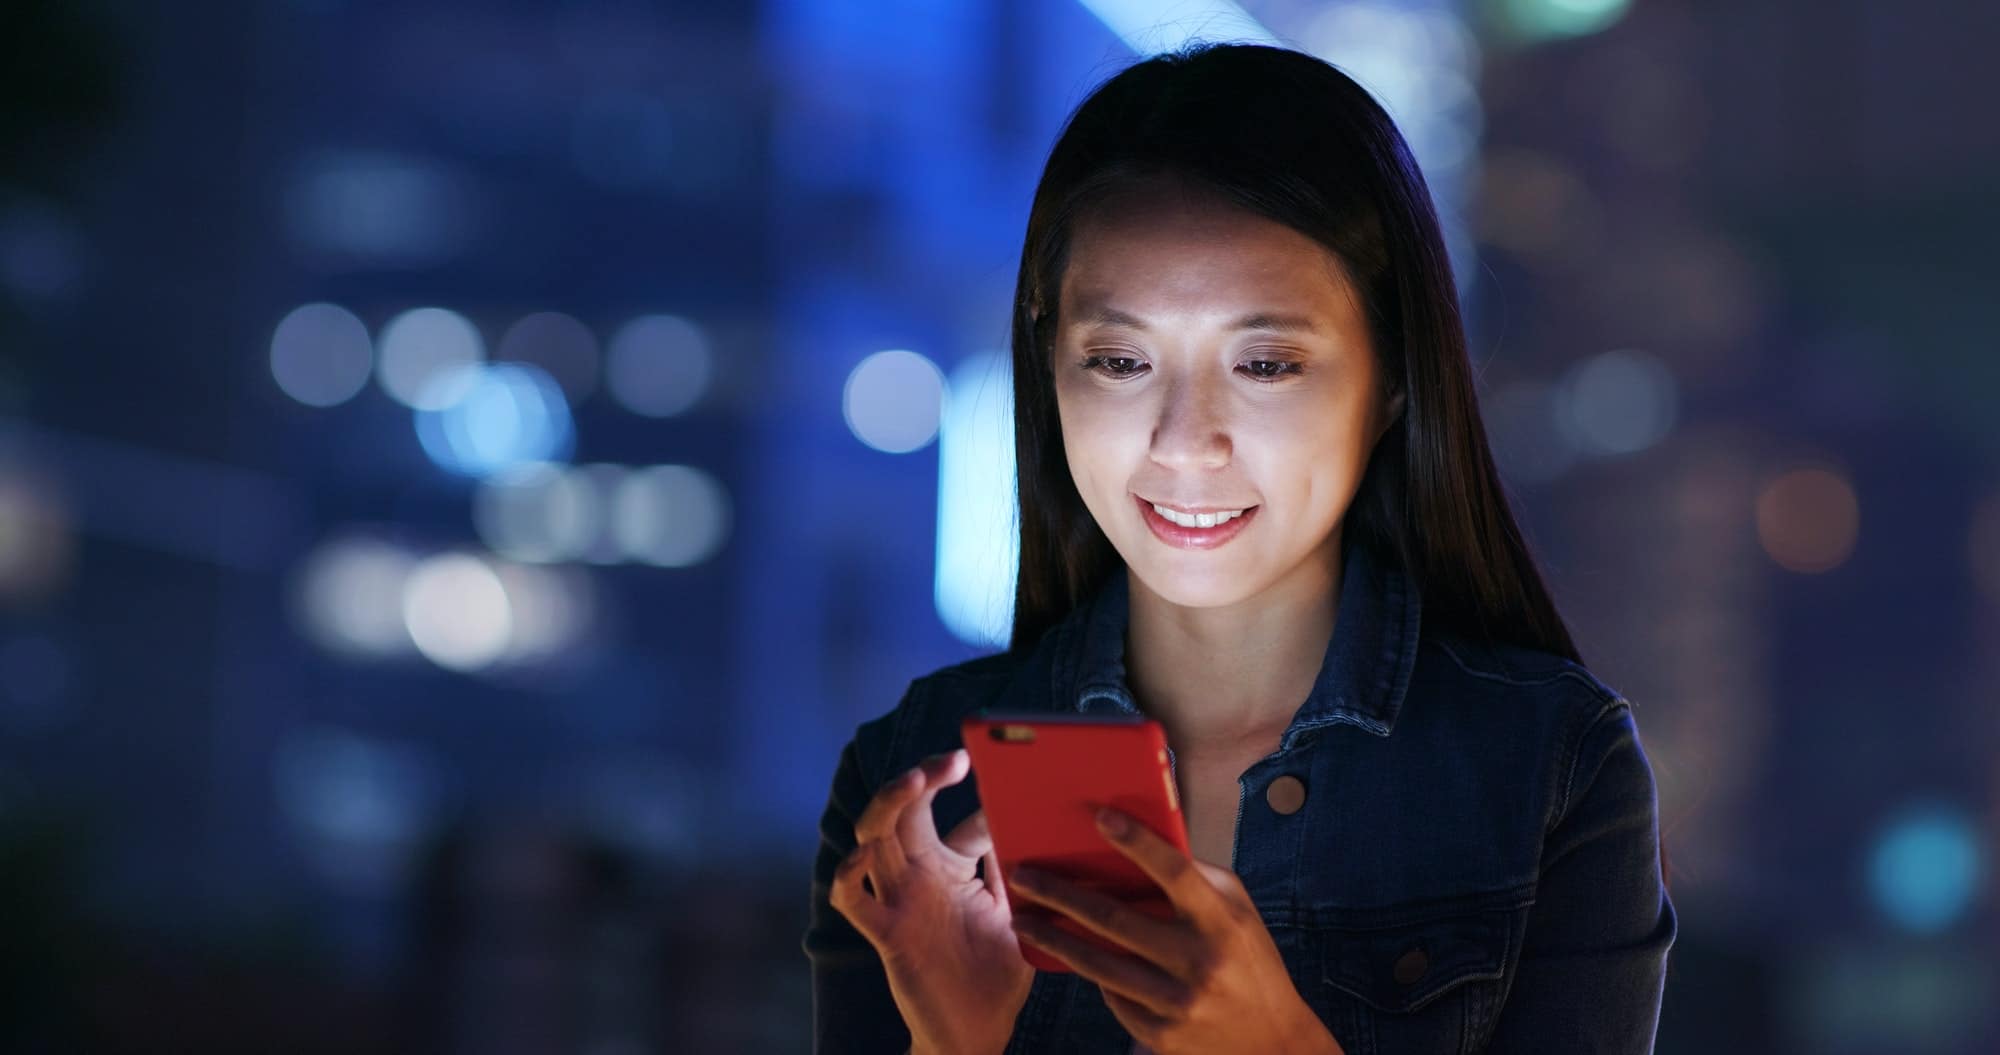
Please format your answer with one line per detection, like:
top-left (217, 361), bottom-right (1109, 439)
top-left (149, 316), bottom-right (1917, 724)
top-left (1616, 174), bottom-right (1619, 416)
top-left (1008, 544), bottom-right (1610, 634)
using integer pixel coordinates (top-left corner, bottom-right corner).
top-left (1050, 531), bottom-right (1422, 749)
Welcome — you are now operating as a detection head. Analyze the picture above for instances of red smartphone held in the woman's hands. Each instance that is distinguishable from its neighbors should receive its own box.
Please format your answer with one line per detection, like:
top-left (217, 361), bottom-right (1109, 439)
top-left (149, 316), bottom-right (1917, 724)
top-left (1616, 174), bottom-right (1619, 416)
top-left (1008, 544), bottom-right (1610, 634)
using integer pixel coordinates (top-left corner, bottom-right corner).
top-left (960, 711), bottom-right (1188, 971)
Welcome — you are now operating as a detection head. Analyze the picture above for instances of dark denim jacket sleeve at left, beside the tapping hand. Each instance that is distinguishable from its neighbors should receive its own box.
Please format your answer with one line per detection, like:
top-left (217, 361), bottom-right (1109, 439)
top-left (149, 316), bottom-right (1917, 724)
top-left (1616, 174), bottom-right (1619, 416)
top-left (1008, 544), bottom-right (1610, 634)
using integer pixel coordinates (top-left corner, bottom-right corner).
top-left (802, 711), bottom-right (910, 1055)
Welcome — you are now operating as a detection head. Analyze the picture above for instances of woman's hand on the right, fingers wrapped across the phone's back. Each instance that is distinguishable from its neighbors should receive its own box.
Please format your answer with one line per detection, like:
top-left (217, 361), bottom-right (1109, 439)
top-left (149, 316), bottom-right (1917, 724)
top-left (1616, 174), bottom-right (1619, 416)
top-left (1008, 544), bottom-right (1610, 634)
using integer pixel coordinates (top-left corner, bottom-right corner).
top-left (1008, 809), bottom-right (1340, 1055)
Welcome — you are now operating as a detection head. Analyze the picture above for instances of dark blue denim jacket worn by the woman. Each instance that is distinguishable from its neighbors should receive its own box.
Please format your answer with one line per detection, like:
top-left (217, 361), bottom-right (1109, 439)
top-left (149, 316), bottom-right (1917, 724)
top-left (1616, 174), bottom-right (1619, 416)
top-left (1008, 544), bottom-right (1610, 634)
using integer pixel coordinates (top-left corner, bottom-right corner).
top-left (804, 545), bottom-right (1678, 1055)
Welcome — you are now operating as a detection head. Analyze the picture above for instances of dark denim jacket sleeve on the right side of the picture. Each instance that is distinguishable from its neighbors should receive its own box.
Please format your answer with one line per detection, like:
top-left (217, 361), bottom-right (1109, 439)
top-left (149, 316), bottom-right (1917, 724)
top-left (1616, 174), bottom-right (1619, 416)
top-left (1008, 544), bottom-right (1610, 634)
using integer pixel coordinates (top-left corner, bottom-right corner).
top-left (1486, 699), bottom-right (1678, 1055)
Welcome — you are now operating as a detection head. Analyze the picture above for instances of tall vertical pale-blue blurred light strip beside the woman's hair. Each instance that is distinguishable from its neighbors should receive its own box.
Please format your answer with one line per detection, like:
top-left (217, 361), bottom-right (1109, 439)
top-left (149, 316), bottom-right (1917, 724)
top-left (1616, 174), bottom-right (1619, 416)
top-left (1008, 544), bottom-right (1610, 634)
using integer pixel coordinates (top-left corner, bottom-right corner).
top-left (934, 352), bottom-right (1020, 647)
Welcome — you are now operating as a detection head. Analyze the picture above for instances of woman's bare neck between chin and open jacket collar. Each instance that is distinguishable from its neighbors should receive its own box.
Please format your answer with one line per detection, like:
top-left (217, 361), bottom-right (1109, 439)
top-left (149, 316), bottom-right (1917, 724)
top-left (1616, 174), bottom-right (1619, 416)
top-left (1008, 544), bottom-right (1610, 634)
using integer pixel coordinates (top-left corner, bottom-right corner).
top-left (1118, 535), bottom-right (1342, 755)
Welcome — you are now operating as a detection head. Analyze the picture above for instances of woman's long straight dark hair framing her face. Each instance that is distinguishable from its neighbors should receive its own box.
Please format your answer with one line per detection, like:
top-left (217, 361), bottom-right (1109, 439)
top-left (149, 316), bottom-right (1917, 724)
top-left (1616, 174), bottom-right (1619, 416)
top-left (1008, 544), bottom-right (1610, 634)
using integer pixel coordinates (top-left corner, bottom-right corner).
top-left (1010, 44), bottom-right (1582, 663)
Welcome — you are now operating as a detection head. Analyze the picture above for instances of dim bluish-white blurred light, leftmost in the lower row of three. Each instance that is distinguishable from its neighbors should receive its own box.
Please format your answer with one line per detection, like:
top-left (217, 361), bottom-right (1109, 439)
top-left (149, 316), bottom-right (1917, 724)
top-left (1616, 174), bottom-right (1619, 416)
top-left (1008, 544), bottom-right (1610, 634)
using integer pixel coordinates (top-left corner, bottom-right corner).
top-left (294, 537), bottom-right (416, 659)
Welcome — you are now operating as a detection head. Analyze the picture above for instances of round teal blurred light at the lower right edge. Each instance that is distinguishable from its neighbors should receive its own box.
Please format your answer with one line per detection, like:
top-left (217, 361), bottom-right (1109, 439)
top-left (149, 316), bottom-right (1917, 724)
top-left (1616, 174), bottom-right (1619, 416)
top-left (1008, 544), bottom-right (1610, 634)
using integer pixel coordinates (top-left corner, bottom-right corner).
top-left (1868, 803), bottom-right (1986, 933)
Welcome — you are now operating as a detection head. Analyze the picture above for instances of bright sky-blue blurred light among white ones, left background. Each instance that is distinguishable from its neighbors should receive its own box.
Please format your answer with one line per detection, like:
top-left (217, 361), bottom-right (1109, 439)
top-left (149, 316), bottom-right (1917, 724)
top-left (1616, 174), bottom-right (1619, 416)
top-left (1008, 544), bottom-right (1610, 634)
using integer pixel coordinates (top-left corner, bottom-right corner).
top-left (416, 364), bottom-right (574, 476)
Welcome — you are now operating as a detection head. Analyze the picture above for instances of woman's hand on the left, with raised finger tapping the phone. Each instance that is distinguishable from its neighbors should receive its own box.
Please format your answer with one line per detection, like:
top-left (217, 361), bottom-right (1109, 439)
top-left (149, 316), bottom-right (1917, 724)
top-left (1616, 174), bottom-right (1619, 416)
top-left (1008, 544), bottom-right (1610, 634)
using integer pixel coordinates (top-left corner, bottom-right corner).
top-left (830, 747), bottom-right (1034, 1055)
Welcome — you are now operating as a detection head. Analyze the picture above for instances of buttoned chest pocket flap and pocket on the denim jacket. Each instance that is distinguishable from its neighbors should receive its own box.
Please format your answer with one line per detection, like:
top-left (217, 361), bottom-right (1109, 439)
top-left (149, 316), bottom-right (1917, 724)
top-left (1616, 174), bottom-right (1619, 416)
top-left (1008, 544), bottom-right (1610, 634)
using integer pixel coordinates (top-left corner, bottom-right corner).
top-left (1312, 907), bottom-right (1528, 1055)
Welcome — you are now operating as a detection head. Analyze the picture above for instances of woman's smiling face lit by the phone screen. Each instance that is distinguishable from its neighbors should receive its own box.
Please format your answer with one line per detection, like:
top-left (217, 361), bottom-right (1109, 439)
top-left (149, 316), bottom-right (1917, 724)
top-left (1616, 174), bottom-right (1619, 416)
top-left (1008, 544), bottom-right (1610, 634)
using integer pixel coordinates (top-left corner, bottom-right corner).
top-left (1052, 184), bottom-right (1402, 607)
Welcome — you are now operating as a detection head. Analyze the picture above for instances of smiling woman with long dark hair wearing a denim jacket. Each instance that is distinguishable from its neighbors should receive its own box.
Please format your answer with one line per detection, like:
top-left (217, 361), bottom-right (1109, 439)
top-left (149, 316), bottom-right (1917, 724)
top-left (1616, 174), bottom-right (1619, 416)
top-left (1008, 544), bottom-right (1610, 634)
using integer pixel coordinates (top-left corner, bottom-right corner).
top-left (804, 46), bottom-right (1676, 1055)
